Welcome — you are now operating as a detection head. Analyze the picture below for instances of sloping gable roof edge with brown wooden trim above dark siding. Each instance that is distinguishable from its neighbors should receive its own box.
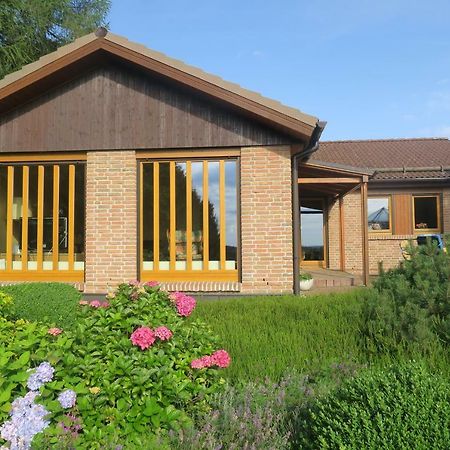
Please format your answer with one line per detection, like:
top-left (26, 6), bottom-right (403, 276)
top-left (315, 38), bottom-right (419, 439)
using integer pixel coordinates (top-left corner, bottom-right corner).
top-left (0, 28), bottom-right (318, 140)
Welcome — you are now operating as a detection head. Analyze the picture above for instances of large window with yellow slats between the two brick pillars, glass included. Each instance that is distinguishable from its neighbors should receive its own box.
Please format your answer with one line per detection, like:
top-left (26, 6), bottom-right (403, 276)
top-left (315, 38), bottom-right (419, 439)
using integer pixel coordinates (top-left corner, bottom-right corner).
top-left (140, 159), bottom-right (238, 281)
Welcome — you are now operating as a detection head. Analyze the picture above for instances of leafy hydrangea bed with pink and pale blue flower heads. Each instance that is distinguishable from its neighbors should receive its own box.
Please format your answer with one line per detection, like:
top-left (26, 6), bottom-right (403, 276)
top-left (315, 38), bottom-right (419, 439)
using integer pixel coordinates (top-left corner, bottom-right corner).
top-left (0, 282), bottom-right (230, 449)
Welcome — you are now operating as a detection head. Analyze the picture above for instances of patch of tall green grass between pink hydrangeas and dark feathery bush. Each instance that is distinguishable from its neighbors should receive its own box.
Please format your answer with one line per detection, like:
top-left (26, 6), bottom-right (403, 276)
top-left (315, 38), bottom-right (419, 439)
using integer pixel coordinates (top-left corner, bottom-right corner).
top-left (193, 290), bottom-right (365, 381)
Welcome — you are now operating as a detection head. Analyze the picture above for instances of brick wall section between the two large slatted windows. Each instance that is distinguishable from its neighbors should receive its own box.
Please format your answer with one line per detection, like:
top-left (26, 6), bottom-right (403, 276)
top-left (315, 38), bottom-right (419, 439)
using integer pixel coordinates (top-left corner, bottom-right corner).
top-left (85, 151), bottom-right (137, 293)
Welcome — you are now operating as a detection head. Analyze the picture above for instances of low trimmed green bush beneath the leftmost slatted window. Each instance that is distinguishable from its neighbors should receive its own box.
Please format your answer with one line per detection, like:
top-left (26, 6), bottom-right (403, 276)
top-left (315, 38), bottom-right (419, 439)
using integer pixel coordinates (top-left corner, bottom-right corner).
top-left (0, 283), bottom-right (81, 329)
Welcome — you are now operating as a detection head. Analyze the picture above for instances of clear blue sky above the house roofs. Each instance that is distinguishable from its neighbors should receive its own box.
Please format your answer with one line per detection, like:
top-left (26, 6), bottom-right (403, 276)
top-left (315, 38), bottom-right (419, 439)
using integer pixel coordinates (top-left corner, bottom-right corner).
top-left (110, 0), bottom-right (450, 139)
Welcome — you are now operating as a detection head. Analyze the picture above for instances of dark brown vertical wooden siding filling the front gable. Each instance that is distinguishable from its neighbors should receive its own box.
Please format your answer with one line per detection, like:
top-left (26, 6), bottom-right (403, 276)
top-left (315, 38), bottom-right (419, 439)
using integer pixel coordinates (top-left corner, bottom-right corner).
top-left (0, 65), bottom-right (291, 152)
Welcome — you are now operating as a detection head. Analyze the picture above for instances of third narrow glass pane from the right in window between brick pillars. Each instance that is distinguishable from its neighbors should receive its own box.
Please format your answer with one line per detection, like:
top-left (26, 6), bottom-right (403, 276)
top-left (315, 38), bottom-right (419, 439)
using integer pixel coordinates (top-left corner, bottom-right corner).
top-left (192, 162), bottom-right (203, 270)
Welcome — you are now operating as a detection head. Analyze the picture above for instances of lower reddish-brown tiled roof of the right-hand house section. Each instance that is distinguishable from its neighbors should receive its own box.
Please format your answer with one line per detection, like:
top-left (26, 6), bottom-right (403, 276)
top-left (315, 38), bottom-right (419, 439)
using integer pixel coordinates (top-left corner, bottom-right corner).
top-left (314, 138), bottom-right (450, 181)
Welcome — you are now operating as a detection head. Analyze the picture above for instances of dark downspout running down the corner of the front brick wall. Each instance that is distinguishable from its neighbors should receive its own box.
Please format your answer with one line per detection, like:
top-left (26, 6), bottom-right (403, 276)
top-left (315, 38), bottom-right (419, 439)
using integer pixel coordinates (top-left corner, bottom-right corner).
top-left (291, 121), bottom-right (327, 295)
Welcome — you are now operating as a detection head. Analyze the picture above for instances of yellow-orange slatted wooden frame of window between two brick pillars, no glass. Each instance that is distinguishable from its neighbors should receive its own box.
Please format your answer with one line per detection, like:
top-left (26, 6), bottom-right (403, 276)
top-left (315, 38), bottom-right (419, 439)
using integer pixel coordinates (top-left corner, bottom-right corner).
top-left (137, 156), bottom-right (241, 282)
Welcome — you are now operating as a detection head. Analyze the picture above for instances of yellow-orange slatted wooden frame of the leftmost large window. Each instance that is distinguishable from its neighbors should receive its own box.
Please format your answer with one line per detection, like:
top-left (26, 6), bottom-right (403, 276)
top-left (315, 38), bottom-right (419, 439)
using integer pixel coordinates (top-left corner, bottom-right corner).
top-left (0, 153), bottom-right (86, 282)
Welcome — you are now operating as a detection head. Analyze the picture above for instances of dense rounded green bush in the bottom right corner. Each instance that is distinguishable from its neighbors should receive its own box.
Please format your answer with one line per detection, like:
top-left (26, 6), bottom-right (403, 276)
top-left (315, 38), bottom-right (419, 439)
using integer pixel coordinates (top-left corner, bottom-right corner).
top-left (301, 363), bottom-right (450, 450)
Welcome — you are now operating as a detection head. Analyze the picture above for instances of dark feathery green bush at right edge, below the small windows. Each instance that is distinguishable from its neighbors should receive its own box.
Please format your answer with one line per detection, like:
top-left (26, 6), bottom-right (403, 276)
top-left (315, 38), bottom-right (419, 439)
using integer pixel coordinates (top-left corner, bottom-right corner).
top-left (362, 244), bottom-right (450, 352)
